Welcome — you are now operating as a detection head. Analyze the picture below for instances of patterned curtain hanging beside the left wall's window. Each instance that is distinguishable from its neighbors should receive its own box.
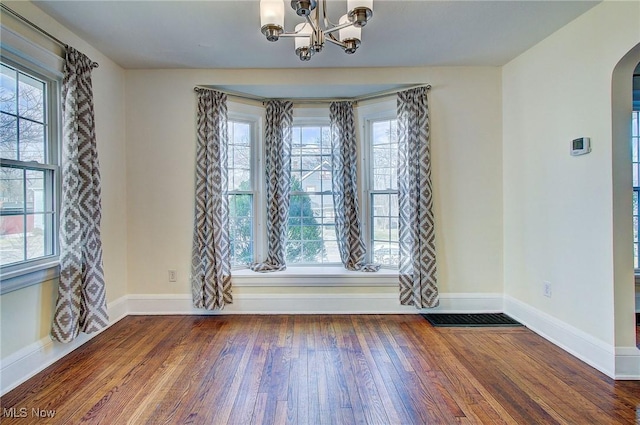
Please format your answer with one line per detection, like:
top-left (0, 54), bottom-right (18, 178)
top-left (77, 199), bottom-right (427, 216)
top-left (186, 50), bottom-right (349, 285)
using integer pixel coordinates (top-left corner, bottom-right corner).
top-left (51, 47), bottom-right (109, 342)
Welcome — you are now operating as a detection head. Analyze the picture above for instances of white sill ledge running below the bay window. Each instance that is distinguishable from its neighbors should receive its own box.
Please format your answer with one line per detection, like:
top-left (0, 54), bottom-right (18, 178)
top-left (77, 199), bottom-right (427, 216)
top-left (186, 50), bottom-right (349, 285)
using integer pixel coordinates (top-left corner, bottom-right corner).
top-left (231, 266), bottom-right (398, 287)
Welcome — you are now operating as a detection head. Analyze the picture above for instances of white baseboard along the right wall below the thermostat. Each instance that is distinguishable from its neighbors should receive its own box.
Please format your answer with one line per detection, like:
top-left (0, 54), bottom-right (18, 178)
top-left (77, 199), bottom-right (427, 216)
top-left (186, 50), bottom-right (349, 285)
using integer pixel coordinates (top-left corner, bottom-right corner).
top-left (504, 295), bottom-right (640, 380)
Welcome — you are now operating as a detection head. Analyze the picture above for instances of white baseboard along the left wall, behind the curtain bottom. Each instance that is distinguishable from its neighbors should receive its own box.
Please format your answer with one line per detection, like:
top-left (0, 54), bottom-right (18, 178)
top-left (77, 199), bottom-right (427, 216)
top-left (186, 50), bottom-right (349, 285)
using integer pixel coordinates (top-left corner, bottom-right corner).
top-left (0, 297), bottom-right (127, 395)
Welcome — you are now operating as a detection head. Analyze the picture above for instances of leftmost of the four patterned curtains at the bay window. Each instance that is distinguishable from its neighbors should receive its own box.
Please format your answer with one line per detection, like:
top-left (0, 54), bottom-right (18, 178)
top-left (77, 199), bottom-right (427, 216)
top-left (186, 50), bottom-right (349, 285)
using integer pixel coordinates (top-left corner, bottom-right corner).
top-left (191, 89), bottom-right (233, 310)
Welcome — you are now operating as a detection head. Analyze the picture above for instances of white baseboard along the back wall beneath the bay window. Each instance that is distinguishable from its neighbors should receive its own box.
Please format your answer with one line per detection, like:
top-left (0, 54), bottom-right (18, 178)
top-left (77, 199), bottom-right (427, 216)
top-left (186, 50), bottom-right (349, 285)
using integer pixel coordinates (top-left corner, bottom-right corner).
top-left (129, 292), bottom-right (502, 315)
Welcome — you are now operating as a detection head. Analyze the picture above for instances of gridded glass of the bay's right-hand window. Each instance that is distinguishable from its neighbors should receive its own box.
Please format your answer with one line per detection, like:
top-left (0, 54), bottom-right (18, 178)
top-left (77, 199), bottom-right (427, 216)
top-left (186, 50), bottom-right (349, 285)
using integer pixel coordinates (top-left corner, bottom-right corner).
top-left (367, 119), bottom-right (399, 267)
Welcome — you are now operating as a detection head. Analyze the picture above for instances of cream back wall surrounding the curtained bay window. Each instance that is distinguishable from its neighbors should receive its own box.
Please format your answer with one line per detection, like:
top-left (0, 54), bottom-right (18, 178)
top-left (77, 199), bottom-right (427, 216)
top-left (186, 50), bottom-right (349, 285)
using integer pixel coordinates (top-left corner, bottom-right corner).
top-left (126, 67), bottom-right (503, 303)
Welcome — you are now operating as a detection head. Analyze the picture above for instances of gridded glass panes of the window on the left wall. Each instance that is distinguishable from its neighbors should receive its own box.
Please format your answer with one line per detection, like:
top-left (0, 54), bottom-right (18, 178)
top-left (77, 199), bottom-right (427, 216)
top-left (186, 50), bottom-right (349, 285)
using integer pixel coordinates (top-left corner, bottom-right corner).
top-left (0, 60), bottom-right (58, 268)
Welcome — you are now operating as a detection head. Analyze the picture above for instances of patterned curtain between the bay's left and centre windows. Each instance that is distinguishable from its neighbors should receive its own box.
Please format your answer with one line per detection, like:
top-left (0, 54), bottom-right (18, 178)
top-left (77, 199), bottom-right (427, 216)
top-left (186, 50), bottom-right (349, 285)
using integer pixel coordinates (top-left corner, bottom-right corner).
top-left (250, 100), bottom-right (293, 272)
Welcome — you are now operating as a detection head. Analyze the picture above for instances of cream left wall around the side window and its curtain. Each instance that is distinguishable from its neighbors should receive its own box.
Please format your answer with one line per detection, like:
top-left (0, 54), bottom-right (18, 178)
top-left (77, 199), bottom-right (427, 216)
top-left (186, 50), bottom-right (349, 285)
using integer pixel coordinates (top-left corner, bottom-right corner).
top-left (0, 2), bottom-right (127, 360)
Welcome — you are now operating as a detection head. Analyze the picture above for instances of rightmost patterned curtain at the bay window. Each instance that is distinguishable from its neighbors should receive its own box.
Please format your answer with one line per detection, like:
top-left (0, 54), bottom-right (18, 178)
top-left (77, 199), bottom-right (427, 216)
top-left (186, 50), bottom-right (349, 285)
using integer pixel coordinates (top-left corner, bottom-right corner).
top-left (398, 87), bottom-right (439, 308)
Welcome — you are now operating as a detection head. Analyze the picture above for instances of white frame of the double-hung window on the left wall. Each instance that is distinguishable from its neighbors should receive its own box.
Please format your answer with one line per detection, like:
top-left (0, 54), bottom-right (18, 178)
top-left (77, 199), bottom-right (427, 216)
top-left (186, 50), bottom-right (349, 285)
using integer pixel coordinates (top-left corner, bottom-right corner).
top-left (0, 36), bottom-right (62, 295)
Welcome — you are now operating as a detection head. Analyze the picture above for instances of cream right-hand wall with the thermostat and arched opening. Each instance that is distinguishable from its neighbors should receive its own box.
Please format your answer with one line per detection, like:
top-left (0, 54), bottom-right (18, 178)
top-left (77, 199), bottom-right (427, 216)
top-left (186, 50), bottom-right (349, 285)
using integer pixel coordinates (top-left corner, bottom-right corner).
top-left (502, 2), bottom-right (640, 354)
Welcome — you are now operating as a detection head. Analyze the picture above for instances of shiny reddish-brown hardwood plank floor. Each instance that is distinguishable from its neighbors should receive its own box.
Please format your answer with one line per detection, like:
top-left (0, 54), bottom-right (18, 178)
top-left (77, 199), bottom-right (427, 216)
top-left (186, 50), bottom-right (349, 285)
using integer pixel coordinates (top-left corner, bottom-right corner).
top-left (0, 315), bottom-right (640, 425)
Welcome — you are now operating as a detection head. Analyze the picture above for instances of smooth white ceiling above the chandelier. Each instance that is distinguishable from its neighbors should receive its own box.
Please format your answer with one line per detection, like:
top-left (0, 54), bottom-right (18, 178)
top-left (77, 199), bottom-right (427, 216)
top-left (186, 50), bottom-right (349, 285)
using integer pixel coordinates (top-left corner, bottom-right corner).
top-left (34, 0), bottom-right (599, 69)
